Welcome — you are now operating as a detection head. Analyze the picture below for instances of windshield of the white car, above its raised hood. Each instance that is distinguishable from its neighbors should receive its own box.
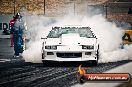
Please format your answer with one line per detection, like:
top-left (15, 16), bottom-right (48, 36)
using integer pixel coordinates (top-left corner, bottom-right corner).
top-left (48, 27), bottom-right (94, 38)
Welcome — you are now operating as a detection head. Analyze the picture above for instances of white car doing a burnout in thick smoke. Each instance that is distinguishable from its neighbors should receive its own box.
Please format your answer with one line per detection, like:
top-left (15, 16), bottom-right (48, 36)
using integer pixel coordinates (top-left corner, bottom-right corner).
top-left (42, 27), bottom-right (99, 65)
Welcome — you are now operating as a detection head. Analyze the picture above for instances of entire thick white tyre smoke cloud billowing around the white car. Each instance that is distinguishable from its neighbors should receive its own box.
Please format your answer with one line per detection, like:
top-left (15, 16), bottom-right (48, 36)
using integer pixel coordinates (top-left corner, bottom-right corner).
top-left (23, 14), bottom-right (132, 62)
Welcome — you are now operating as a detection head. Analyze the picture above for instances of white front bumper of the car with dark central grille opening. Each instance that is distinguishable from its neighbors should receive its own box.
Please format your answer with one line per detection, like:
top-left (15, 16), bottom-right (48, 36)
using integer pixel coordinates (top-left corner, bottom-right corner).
top-left (42, 51), bottom-right (97, 62)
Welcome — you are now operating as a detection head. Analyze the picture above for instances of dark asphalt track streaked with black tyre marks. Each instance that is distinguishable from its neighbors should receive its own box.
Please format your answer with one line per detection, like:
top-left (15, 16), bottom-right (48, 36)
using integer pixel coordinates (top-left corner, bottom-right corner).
top-left (0, 39), bottom-right (131, 87)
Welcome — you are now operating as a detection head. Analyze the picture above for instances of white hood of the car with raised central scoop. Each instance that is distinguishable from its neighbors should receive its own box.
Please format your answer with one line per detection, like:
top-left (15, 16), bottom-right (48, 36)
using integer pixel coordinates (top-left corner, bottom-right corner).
top-left (45, 34), bottom-right (97, 45)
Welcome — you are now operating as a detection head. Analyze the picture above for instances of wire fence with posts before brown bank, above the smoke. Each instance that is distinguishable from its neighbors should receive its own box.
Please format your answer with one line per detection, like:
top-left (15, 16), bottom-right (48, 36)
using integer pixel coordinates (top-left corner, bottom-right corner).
top-left (0, 0), bottom-right (132, 29)
